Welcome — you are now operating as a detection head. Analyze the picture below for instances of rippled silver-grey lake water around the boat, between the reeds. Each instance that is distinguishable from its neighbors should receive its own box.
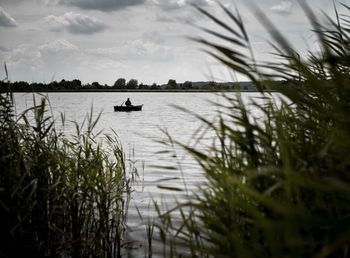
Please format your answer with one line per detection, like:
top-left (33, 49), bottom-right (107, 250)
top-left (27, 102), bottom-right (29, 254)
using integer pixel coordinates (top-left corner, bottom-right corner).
top-left (15, 92), bottom-right (270, 255)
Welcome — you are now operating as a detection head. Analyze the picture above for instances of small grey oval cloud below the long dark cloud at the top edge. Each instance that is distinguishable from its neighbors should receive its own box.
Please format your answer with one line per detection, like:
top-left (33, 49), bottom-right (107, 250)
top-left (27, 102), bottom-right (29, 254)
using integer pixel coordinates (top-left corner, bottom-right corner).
top-left (44, 12), bottom-right (107, 34)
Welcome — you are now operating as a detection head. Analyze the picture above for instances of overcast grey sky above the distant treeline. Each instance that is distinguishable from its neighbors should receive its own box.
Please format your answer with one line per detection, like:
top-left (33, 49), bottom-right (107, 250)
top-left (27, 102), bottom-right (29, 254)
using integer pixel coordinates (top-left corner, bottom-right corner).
top-left (0, 0), bottom-right (344, 85)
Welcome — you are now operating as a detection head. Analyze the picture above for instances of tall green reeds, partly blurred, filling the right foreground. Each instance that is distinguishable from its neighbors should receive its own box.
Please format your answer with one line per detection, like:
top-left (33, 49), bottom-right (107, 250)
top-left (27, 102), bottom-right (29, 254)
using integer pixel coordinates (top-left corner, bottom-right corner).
top-left (155, 1), bottom-right (350, 257)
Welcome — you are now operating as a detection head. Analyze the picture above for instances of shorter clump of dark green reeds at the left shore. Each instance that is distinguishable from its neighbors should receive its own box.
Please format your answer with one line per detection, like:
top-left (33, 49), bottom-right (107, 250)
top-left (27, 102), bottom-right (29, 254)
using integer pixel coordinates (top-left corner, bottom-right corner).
top-left (0, 93), bottom-right (136, 257)
